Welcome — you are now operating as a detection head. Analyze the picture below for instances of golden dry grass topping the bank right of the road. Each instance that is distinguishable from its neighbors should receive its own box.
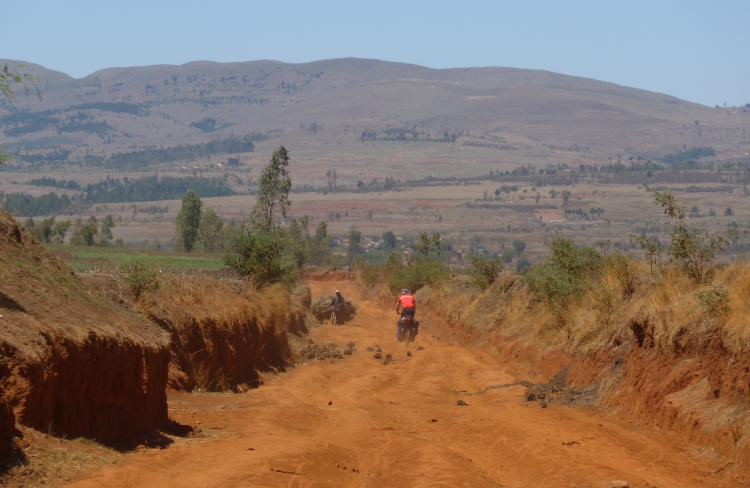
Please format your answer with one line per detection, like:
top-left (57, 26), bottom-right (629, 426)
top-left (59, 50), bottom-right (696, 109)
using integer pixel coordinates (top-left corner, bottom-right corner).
top-left (418, 261), bottom-right (750, 354)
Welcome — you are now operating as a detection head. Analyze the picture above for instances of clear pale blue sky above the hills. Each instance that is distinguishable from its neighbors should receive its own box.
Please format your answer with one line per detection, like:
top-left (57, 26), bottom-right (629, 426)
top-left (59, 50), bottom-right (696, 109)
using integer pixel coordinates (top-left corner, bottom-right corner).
top-left (0, 0), bottom-right (750, 106)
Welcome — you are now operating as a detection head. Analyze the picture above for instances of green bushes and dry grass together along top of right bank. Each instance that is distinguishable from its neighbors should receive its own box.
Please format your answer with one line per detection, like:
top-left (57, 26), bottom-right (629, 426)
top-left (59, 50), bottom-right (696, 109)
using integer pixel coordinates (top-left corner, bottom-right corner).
top-left (356, 189), bottom-right (750, 353)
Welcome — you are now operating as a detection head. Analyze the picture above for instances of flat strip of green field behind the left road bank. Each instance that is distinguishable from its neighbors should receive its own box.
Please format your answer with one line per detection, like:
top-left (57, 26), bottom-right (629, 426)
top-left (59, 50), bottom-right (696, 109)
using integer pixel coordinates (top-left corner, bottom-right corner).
top-left (44, 244), bottom-right (225, 273)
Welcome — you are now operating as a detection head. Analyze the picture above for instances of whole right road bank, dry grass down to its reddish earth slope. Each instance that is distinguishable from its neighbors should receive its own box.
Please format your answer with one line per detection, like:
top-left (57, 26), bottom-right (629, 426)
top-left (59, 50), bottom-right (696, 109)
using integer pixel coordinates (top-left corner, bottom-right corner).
top-left (362, 261), bottom-right (750, 470)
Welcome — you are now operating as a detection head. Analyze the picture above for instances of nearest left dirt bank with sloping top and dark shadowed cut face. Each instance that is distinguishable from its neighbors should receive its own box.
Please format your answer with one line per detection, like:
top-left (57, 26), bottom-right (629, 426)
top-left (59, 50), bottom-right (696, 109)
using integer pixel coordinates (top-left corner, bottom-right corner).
top-left (0, 211), bottom-right (169, 443)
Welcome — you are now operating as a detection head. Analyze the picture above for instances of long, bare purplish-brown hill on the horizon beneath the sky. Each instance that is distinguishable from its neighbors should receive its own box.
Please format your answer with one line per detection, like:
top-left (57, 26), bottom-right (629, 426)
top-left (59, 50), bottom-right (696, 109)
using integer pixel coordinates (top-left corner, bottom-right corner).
top-left (0, 58), bottom-right (750, 176)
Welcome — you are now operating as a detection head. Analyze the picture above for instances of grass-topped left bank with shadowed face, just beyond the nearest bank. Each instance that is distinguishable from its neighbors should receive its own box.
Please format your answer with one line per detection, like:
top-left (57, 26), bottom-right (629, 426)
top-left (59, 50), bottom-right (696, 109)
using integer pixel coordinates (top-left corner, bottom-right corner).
top-left (134, 275), bottom-right (310, 391)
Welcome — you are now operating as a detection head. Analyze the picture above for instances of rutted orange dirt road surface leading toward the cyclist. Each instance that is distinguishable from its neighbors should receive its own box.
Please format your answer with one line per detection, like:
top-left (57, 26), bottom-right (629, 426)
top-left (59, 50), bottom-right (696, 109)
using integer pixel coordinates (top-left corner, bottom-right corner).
top-left (69, 281), bottom-right (742, 487)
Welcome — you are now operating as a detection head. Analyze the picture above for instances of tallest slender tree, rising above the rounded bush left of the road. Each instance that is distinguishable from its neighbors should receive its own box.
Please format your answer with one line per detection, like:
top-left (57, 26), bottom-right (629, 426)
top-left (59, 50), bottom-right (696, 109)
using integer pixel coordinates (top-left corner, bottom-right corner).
top-left (252, 146), bottom-right (292, 229)
